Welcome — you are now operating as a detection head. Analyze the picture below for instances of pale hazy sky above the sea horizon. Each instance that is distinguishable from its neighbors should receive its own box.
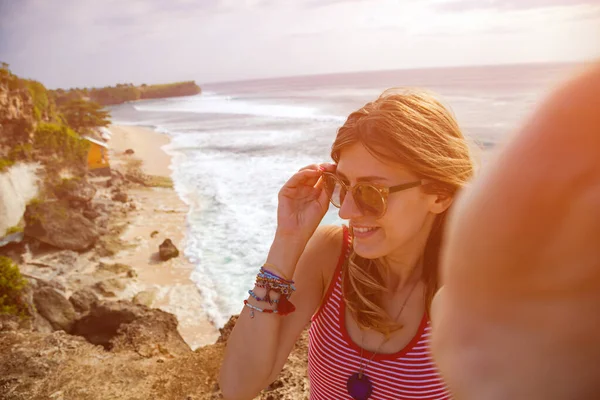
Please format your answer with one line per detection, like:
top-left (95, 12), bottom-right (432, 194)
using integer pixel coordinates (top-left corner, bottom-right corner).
top-left (0, 0), bottom-right (600, 88)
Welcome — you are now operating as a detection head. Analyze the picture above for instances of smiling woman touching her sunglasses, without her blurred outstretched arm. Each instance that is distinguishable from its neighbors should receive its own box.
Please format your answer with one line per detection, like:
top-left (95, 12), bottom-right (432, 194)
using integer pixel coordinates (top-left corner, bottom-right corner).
top-left (220, 91), bottom-right (473, 399)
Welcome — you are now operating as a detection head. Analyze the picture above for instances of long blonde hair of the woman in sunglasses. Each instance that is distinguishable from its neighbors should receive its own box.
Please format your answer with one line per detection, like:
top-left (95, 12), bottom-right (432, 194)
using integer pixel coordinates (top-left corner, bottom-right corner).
top-left (331, 89), bottom-right (474, 334)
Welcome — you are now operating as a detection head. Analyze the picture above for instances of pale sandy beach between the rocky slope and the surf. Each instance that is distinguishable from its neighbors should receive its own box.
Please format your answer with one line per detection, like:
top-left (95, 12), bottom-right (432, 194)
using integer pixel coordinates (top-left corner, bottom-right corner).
top-left (106, 125), bottom-right (218, 349)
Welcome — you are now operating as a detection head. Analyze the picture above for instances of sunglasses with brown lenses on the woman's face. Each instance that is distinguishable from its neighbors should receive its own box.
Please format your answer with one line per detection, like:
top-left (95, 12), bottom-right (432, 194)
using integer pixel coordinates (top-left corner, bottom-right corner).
top-left (323, 172), bottom-right (423, 218)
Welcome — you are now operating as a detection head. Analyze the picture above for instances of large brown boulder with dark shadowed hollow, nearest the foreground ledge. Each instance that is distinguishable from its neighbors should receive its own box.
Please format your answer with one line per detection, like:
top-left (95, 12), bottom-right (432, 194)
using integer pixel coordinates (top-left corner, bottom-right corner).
top-left (73, 301), bottom-right (191, 357)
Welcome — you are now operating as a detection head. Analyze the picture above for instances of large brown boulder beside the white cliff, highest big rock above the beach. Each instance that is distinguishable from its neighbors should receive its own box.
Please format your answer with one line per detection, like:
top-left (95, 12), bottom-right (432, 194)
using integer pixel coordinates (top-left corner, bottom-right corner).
top-left (24, 202), bottom-right (99, 251)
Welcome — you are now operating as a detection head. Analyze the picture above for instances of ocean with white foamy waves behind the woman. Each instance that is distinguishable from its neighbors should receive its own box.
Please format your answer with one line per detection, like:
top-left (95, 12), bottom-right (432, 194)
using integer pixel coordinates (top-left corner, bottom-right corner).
top-left (111, 64), bottom-right (573, 326)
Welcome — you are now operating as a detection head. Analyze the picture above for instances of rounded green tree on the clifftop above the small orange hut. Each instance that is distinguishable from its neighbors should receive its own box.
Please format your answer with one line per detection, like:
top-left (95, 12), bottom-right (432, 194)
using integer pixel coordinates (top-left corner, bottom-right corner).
top-left (59, 99), bottom-right (110, 133)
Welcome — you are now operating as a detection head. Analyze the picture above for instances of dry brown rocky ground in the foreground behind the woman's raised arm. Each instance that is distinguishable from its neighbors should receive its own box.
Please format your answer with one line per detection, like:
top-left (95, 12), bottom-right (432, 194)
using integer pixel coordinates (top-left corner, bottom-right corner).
top-left (0, 305), bottom-right (309, 400)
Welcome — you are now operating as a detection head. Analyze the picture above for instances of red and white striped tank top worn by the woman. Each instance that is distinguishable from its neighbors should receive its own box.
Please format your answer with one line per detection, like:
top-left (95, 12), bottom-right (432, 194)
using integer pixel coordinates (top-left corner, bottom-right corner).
top-left (308, 227), bottom-right (450, 400)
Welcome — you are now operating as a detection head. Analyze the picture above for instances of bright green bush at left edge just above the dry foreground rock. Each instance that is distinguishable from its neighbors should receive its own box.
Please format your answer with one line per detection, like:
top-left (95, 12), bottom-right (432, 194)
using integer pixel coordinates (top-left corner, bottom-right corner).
top-left (0, 256), bottom-right (27, 316)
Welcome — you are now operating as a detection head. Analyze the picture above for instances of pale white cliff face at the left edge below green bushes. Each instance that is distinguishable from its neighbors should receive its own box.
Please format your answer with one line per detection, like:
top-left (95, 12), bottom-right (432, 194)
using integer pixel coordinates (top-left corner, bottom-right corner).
top-left (0, 163), bottom-right (39, 233)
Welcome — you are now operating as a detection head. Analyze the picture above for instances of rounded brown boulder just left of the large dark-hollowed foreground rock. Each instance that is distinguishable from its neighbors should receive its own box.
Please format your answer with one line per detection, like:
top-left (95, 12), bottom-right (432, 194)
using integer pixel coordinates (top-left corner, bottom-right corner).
top-left (33, 286), bottom-right (75, 333)
